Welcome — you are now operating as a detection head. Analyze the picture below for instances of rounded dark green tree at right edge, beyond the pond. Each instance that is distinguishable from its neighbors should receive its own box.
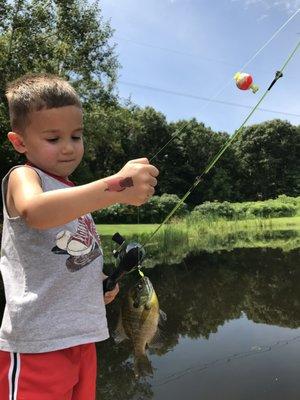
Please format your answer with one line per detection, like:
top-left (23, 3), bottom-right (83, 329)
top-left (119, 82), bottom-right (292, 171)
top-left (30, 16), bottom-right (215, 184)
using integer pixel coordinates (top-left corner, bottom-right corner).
top-left (234, 120), bottom-right (300, 200)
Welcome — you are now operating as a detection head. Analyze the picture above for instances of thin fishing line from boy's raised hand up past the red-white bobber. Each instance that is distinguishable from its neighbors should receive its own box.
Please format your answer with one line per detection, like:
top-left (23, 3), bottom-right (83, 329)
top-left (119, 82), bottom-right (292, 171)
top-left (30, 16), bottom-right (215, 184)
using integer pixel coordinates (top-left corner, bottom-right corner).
top-left (149, 8), bottom-right (300, 163)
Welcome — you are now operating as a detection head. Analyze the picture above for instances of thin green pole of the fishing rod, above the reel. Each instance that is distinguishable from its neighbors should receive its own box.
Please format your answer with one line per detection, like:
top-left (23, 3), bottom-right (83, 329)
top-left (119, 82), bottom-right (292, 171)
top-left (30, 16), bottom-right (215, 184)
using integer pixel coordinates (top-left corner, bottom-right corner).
top-left (142, 40), bottom-right (300, 250)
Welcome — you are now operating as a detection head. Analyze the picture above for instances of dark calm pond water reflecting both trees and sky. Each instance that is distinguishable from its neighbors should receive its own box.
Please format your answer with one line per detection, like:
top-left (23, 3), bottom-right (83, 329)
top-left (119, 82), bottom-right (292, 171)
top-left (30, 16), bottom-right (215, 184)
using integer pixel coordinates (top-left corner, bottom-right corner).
top-left (97, 248), bottom-right (300, 400)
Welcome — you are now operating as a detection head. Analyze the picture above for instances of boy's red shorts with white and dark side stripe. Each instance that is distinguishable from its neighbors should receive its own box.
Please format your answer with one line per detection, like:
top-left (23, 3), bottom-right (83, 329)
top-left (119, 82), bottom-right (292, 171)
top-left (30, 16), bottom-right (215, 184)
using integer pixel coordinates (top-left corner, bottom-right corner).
top-left (0, 343), bottom-right (97, 400)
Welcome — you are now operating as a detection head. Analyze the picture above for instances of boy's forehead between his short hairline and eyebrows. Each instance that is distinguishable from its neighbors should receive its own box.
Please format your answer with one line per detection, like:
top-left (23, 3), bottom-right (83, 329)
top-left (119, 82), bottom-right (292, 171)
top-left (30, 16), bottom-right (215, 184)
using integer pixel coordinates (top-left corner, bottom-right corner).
top-left (28, 106), bottom-right (83, 131)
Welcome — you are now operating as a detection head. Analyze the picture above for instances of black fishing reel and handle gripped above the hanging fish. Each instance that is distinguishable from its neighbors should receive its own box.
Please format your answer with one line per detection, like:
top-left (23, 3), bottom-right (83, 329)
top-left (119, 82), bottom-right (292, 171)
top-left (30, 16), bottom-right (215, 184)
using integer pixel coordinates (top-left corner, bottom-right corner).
top-left (103, 232), bottom-right (146, 293)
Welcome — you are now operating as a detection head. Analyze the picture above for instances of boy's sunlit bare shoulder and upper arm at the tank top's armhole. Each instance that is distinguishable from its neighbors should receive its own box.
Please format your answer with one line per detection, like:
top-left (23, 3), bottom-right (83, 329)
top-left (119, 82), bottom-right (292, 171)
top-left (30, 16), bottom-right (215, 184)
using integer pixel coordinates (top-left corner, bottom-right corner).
top-left (6, 165), bottom-right (43, 217)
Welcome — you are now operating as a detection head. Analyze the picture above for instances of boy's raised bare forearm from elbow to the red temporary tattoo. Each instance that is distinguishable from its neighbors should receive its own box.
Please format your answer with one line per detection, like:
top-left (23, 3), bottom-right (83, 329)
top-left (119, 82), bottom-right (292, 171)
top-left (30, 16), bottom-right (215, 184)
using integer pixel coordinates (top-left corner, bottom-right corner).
top-left (23, 180), bottom-right (119, 229)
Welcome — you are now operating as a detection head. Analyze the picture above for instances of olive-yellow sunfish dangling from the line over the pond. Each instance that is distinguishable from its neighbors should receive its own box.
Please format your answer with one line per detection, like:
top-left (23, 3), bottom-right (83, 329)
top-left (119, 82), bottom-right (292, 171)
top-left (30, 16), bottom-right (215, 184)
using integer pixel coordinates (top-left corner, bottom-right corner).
top-left (114, 276), bottom-right (166, 378)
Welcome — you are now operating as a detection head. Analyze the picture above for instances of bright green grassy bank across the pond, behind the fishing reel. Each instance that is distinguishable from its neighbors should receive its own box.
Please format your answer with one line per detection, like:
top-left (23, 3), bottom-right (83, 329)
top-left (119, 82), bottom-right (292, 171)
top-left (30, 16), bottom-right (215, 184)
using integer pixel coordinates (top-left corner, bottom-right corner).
top-left (97, 216), bottom-right (300, 267)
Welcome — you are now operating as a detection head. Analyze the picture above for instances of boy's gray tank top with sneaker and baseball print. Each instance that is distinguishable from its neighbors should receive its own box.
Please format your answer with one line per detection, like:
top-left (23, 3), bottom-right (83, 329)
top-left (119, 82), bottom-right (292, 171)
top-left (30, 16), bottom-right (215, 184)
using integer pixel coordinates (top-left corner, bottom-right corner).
top-left (0, 167), bottom-right (109, 353)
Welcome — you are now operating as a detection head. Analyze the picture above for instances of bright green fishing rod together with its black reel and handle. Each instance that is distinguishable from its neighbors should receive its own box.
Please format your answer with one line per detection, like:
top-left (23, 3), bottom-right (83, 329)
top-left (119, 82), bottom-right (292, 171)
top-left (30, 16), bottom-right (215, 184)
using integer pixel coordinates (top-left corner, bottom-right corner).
top-left (103, 40), bottom-right (300, 291)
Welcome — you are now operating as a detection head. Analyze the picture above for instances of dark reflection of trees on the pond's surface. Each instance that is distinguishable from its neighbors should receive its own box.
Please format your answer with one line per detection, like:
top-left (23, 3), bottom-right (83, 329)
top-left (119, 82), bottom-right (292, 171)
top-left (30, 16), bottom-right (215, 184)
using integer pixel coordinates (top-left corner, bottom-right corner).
top-left (97, 248), bottom-right (300, 400)
